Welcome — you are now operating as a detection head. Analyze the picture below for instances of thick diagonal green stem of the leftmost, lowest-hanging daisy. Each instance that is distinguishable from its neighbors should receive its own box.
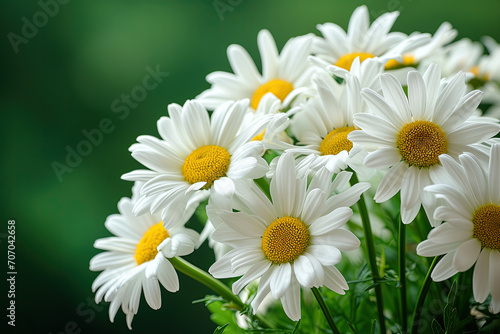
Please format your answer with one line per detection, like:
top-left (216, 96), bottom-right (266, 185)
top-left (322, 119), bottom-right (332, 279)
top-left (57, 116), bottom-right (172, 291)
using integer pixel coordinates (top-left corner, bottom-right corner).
top-left (168, 257), bottom-right (273, 328)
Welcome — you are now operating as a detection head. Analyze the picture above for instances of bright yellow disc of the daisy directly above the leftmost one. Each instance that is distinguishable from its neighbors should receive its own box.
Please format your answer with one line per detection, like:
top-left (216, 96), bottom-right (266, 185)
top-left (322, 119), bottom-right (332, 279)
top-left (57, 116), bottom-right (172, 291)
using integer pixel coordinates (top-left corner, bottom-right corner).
top-left (182, 145), bottom-right (231, 189)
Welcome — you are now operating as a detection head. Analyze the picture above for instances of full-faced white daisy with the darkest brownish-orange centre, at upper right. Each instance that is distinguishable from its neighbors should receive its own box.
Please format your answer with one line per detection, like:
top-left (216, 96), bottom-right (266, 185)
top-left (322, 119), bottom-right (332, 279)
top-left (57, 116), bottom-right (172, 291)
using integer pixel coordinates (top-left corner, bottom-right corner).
top-left (348, 64), bottom-right (500, 224)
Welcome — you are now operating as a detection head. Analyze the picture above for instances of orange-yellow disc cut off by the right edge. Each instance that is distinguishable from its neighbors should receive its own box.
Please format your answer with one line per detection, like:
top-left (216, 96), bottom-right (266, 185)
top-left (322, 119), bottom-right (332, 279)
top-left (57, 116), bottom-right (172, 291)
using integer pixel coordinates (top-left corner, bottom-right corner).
top-left (472, 204), bottom-right (500, 250)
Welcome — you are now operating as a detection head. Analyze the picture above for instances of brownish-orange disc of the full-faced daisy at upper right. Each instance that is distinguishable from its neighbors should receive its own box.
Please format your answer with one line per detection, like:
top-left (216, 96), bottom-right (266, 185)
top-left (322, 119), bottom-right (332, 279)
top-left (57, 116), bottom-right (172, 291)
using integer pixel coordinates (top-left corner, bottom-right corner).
top-left (396, 121), bottom-right (448, 168)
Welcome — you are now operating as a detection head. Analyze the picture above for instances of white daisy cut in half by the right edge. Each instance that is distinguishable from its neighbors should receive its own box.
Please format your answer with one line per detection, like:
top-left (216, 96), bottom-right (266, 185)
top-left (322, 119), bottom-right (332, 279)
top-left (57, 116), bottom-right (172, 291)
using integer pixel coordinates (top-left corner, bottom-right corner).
top-left (417, 144), bottom-right (500, 313)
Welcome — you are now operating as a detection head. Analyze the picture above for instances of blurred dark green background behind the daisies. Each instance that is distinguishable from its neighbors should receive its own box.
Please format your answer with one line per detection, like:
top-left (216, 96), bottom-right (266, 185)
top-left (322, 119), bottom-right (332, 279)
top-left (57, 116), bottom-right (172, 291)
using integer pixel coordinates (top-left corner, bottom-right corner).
top-left (0, 0), bottom-right (500, 334)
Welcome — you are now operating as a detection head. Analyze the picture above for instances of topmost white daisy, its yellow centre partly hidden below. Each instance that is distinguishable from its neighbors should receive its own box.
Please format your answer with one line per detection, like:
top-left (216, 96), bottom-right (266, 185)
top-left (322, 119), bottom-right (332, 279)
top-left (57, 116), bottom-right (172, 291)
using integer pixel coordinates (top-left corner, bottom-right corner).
top-left (313, 6), bottom-right (430, 70)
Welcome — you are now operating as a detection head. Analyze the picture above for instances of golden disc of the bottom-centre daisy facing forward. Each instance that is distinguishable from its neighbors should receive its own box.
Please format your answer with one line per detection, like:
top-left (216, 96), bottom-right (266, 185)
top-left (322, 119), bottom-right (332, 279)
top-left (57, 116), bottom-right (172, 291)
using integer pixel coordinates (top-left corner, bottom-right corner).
top-left (262, 217), bottom-right (310, 264)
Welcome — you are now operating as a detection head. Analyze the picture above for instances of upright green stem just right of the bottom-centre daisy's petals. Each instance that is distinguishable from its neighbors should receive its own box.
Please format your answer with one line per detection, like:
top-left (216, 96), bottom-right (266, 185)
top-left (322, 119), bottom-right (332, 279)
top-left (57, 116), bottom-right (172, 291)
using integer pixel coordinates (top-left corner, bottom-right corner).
top-left (350, 172), bottom-right (386, 333)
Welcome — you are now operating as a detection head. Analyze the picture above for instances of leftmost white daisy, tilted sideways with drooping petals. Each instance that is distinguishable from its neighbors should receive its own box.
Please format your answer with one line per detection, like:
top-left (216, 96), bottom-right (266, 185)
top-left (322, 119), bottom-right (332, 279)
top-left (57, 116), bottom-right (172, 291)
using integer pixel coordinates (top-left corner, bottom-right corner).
top-left (90, 184), bottom-right (199, 329)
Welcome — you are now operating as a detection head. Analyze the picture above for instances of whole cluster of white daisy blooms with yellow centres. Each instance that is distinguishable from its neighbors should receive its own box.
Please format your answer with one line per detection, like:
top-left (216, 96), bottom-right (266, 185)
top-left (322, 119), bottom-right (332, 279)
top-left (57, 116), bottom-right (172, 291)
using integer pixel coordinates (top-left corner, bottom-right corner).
top-left (90, 6), bottom-right (500, 327)
